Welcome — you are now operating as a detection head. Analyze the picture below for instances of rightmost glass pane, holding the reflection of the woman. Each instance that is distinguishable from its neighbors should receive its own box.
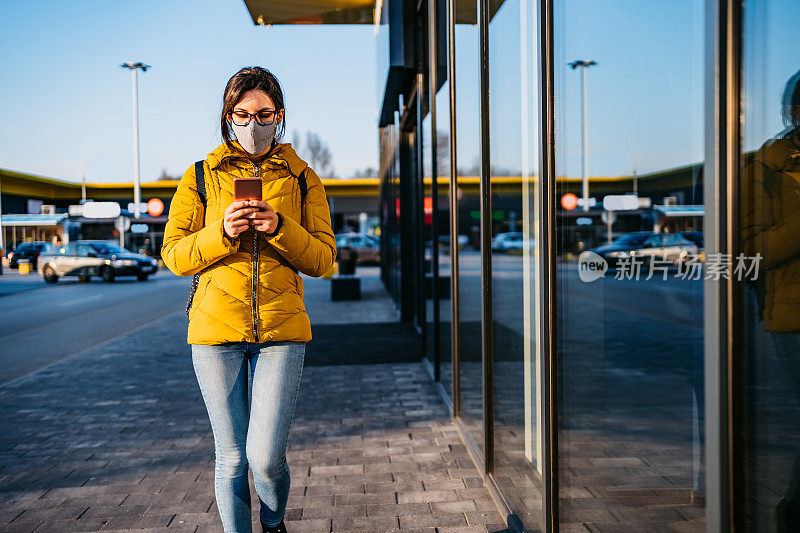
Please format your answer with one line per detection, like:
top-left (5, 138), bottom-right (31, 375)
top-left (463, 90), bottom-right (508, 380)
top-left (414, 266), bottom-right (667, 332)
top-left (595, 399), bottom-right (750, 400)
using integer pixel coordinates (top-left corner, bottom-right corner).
top-left (731, 0), bottom-right (800, 532)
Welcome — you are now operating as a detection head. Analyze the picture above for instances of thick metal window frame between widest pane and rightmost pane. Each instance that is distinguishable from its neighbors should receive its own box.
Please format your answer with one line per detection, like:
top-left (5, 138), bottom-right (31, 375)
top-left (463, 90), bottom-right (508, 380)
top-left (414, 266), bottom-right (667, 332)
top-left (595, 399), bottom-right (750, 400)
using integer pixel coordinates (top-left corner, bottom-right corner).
top-left (703, 0), bottom-right (745, 532)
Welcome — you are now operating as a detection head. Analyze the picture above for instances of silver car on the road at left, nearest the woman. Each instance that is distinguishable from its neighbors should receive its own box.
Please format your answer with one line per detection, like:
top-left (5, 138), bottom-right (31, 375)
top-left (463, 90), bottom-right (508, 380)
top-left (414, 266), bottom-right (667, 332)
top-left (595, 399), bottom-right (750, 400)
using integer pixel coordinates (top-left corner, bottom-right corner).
top-left (38, 240), bottom-right (158, 283)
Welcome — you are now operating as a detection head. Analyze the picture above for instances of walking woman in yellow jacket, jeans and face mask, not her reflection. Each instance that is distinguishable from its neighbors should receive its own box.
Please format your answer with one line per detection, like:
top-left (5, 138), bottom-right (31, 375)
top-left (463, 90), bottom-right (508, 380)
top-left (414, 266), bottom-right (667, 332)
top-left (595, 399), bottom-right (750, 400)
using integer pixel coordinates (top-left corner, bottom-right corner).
top-left (161, 67), bottom-right (336, 533)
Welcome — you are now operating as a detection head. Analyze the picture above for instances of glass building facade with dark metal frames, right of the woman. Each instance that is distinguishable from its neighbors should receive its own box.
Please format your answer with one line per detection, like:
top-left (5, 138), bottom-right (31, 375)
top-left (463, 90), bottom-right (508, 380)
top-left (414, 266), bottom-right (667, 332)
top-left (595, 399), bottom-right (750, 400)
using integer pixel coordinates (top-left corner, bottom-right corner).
top-left (368, 0), bottom-right (800, 531)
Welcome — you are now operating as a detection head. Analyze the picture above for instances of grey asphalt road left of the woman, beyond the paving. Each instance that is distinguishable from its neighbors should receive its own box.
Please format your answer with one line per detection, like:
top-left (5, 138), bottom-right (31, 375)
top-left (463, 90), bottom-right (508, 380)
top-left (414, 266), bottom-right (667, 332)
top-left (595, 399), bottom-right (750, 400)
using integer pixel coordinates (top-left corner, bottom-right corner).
top-left (0, 269), bottom-right (191, 384)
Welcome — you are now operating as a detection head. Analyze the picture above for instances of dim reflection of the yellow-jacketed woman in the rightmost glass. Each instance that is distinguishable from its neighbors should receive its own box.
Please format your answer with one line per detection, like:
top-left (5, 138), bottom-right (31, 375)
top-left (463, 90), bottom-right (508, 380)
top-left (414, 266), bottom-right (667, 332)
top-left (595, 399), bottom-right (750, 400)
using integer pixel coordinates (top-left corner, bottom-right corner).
top-left (742, 71), bottom-right (800, 531)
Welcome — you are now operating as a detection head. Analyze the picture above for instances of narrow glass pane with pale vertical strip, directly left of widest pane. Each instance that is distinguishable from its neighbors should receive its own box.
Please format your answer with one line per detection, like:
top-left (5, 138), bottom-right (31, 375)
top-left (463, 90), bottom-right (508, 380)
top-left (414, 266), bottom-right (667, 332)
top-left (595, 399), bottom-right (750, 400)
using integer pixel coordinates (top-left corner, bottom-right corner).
top-left (489, 0), bottom-right (542, 531)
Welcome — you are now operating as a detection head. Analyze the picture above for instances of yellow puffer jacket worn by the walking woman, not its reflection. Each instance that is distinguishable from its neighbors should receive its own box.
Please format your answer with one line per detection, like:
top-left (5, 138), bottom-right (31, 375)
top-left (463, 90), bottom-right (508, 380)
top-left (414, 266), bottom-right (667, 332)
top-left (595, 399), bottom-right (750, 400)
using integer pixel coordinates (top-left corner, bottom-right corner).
top-left (161, 141), bottom-right (336, 344)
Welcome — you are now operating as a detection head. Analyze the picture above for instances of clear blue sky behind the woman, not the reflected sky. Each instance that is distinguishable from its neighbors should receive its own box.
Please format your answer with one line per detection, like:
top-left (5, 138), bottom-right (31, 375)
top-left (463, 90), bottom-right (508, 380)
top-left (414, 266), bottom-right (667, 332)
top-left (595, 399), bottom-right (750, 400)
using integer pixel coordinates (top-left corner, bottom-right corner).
top-left (0, 0), bottom-right (378, 182)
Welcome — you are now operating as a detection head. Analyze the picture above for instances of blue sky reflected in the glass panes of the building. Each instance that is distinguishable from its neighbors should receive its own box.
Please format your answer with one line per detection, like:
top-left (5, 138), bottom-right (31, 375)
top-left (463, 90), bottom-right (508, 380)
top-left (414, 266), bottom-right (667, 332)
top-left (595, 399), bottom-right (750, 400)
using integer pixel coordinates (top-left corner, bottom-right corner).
top-left (454, 0), bottom-right (800, 180)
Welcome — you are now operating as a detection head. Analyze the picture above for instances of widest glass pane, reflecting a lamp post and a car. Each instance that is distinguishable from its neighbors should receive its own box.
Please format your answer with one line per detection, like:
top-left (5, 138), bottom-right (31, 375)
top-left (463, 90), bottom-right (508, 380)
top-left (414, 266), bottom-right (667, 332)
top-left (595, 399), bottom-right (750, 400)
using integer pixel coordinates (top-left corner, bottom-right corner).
top-left (555, 0), bottom-right (705, 531)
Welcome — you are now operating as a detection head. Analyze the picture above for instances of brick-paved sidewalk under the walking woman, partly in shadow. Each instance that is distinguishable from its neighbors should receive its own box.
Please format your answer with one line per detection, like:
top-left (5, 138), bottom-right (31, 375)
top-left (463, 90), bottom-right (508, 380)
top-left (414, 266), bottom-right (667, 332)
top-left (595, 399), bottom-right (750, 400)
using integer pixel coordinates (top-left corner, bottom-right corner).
top-left (0, 306), bottom-right (505, 533)
